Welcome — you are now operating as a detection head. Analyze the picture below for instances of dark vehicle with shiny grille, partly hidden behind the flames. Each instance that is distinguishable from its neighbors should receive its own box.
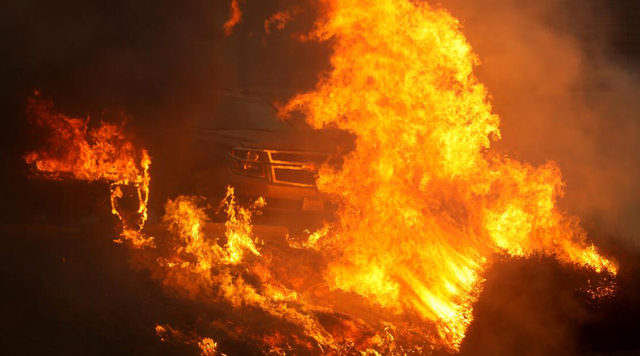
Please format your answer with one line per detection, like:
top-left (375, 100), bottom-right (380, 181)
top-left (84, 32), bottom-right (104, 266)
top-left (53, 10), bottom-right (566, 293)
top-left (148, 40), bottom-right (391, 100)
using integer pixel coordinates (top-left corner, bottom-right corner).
top-left (184, 89), bottom-right (353, 230)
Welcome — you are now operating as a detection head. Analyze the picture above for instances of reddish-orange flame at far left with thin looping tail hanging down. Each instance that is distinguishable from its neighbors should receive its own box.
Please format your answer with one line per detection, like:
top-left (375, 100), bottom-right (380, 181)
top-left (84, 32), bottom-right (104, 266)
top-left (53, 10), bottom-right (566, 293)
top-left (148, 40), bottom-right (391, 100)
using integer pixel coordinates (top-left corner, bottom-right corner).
top-left (25, 92), bottom-right (153, 247)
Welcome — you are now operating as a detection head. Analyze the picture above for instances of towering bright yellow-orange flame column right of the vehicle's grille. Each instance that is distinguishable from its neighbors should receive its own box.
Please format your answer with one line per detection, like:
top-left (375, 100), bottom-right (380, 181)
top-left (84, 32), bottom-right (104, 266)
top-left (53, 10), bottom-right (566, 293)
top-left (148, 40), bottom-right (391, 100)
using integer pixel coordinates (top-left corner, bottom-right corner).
top-left (285, 0), bottom-right (615, 350)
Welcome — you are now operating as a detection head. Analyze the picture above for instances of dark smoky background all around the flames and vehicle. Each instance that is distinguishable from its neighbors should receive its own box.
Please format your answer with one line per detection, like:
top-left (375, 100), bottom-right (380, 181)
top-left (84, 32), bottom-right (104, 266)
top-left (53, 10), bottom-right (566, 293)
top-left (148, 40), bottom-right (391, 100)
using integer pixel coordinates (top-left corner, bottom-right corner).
top-left (0, 0), bottom-right (640, 355)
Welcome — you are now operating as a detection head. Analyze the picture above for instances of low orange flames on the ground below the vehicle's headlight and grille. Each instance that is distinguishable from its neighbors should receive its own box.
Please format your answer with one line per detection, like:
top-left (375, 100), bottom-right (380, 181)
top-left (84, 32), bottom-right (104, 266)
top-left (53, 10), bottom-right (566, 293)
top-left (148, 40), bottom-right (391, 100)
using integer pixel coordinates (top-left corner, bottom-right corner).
top-left (158, 187), bottom-right (332, 345)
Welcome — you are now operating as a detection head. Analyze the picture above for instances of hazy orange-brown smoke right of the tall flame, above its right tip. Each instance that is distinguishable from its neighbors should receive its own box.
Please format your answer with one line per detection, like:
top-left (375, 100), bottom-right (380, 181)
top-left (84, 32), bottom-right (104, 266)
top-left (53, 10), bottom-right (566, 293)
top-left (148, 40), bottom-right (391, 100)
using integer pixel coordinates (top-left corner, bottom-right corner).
top-left (442, 0), bottom-right (640, 246)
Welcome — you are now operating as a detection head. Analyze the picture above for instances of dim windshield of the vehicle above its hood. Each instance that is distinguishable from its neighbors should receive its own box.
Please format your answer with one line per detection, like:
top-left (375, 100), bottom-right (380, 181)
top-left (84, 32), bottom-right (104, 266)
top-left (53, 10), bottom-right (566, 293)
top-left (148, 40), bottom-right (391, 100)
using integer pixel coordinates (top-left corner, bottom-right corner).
top-left (198, 97), bottom-right (293, 132)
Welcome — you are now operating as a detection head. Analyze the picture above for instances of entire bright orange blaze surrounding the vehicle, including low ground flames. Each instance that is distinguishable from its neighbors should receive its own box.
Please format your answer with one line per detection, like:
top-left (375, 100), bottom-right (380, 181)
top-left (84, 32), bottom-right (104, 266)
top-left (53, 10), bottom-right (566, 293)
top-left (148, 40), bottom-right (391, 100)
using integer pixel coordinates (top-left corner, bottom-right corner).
top-left (25, 0), bottom-right (617, 355)
